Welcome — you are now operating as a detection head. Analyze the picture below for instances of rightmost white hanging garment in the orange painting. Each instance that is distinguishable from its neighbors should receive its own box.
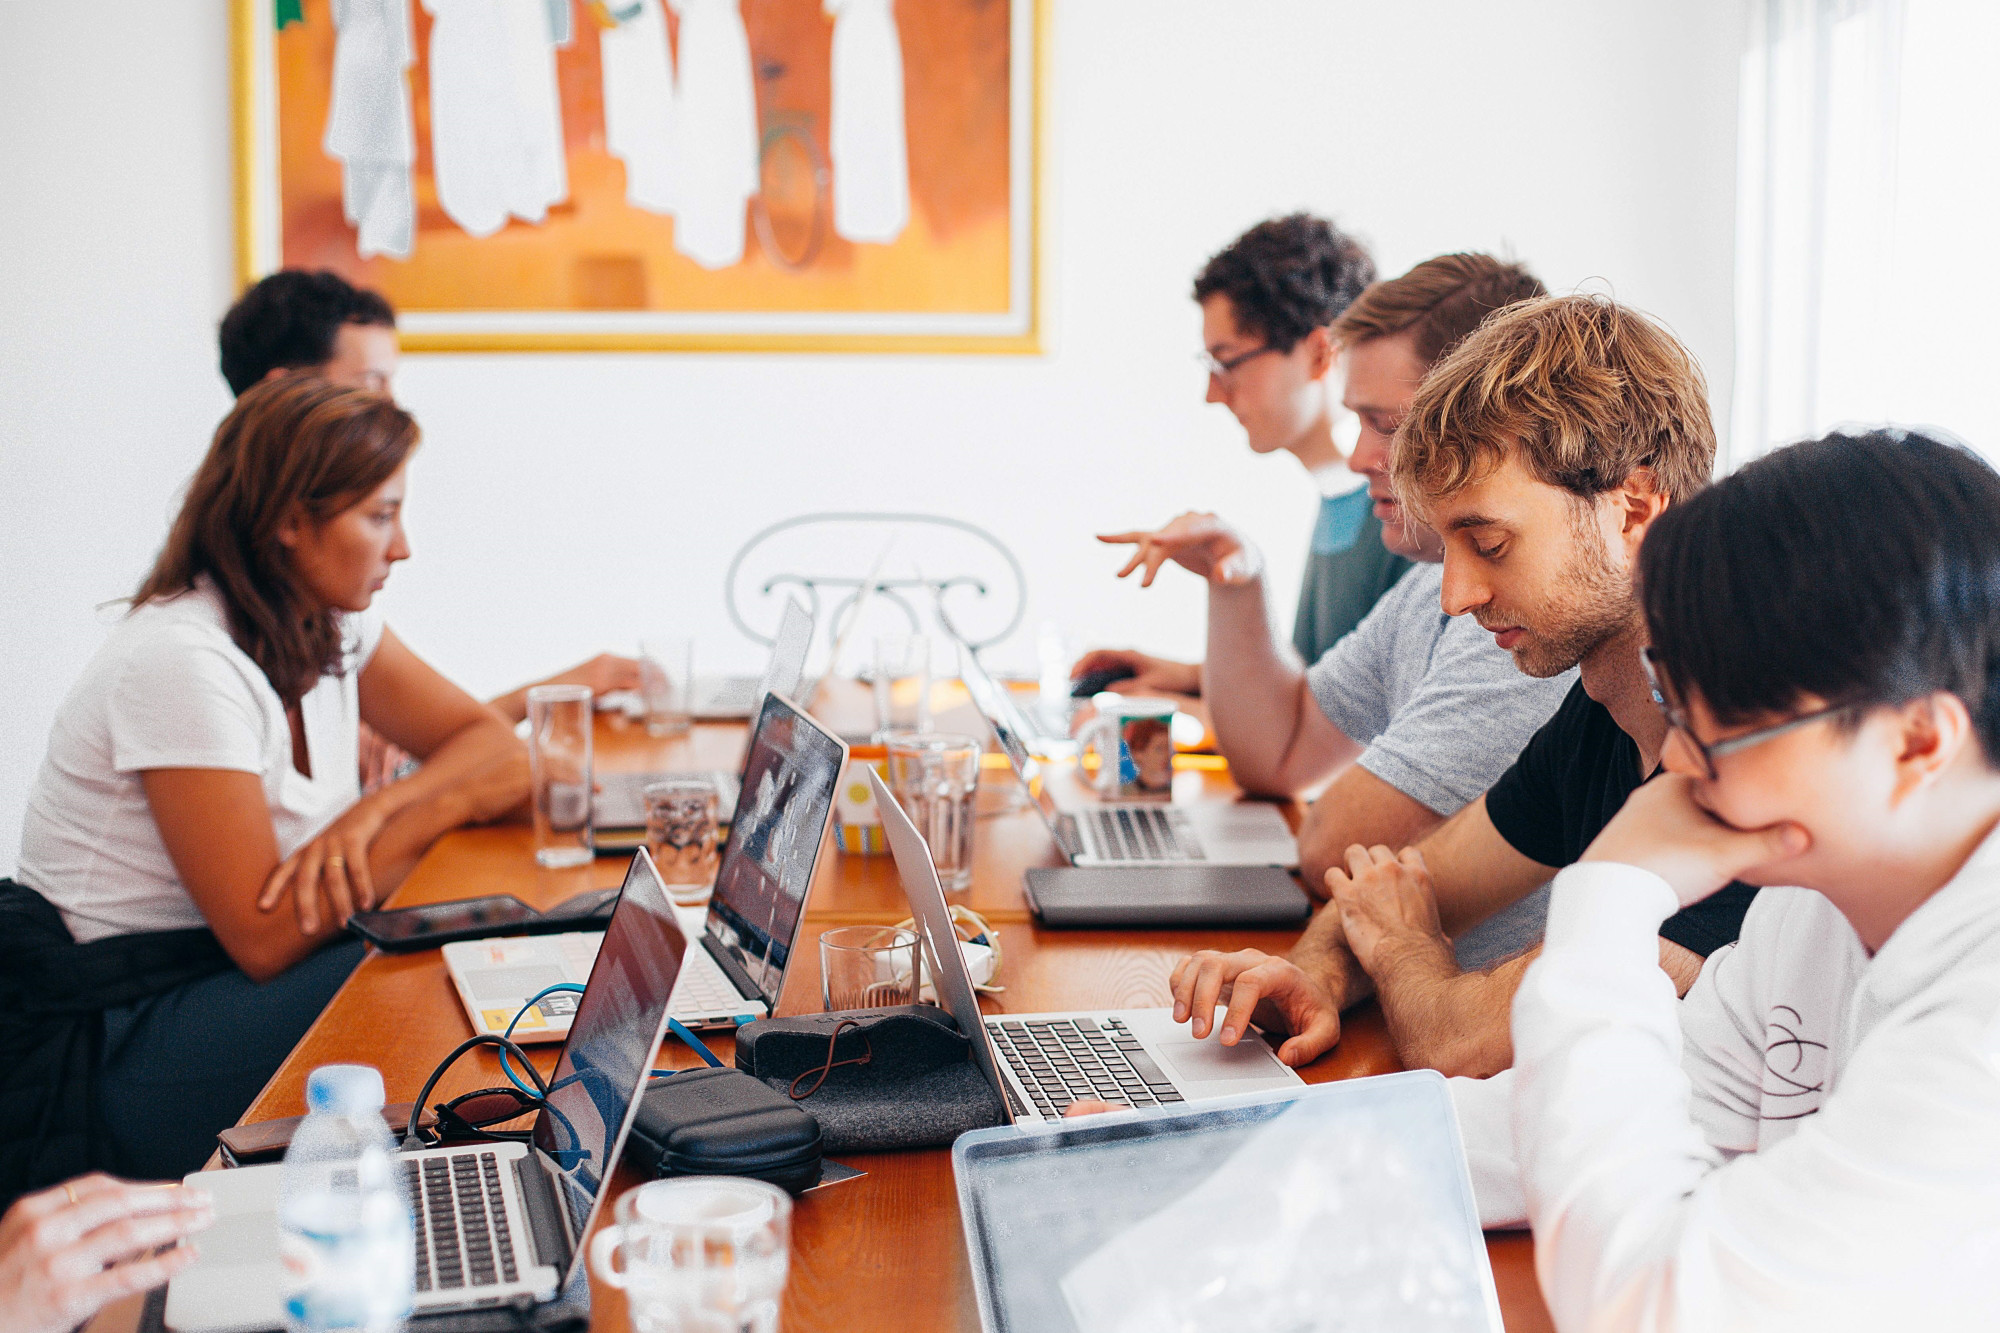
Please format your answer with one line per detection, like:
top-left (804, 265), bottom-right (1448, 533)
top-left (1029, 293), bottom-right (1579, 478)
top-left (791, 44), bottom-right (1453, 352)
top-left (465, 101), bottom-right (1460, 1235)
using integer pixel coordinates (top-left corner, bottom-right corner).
top-left (826, 0), bottom-right (910, 244)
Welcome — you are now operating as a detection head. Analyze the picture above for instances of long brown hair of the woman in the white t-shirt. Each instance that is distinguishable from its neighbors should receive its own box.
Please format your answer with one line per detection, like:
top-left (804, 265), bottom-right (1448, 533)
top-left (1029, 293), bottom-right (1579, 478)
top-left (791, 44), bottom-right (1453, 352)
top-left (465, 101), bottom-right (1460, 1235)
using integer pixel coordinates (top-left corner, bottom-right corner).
top-left (132, 374), bottom-right (418, 705)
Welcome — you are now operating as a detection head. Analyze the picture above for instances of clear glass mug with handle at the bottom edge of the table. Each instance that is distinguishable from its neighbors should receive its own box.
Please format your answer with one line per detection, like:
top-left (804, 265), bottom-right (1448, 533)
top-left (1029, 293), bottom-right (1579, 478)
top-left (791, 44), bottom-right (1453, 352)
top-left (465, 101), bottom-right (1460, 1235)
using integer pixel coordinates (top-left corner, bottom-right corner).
top-left (590, 1175), bottom-right (792, 1333)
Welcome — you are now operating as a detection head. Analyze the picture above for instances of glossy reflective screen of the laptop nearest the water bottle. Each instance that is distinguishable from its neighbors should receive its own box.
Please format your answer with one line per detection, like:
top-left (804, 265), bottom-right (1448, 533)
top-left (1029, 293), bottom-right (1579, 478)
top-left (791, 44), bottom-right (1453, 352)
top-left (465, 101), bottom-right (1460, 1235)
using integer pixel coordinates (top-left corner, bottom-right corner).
top-left (534, 853), bottom-right (688, 1237)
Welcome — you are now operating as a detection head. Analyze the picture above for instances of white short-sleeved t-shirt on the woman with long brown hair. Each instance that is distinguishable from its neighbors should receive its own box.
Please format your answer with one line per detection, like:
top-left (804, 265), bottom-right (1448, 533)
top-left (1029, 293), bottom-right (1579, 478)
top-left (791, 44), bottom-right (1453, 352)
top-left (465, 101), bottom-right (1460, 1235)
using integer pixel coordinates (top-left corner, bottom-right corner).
top-left (16, 578), bottom-right (382, 943)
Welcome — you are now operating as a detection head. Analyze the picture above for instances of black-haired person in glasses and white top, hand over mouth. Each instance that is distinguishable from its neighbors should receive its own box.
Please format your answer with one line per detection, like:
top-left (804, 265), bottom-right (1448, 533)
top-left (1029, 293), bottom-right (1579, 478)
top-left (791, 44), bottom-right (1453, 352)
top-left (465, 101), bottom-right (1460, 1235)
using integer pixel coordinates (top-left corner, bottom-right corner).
top-left (1452, 430), bottom-right (2000, 1333)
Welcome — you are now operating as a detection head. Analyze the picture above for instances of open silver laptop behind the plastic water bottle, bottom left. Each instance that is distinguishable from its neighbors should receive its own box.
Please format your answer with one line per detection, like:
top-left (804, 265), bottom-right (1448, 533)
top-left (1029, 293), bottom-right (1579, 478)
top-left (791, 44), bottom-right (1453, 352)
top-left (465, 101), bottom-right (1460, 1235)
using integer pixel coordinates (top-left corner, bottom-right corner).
top-left (164, 851), bottom-right (688, 1333)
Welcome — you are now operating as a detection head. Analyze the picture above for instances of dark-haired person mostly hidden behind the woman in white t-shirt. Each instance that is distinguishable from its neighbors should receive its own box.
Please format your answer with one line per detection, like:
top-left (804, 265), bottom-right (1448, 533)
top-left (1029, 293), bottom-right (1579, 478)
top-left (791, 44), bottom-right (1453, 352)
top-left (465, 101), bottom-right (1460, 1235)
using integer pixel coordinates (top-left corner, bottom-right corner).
top-left (218, 268), bottom-right (638, 764)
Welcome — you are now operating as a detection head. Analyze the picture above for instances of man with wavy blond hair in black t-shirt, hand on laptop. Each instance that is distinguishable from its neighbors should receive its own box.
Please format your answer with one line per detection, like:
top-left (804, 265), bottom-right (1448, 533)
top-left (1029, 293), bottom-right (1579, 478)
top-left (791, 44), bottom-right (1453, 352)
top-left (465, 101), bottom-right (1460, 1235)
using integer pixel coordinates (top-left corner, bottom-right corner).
top-left (1174, 296), bottom-right (1754, 1075)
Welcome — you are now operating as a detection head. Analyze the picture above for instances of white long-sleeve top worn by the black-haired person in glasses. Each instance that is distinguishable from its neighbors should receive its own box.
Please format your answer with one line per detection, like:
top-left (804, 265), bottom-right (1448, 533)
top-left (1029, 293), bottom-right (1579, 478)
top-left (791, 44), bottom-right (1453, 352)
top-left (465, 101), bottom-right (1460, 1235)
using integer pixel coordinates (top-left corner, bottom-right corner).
top-left (1452, 835), bottom-right (2000, 1333)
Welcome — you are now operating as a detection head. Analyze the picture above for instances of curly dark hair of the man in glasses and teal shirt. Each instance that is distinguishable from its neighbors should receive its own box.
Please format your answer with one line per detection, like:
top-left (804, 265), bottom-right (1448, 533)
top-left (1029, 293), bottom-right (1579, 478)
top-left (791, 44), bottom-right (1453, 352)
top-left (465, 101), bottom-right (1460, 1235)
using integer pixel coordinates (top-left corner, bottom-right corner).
top-left (1194, 212), bottom-right (1374, 352)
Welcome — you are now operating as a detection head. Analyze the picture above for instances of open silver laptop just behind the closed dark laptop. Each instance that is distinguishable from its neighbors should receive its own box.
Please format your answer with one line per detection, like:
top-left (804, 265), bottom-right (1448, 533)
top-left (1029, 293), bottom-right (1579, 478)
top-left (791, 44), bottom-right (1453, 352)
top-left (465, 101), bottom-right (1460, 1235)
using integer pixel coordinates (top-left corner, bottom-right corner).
top-left (958, 650), bottom-right (1298, 869)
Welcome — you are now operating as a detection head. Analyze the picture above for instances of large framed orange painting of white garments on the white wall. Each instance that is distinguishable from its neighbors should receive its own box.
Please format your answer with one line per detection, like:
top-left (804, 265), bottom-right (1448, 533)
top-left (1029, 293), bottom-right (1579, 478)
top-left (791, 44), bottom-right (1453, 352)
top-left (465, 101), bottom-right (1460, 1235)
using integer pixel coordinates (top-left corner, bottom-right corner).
top-left (232, 0), bottom-right (1050, 352)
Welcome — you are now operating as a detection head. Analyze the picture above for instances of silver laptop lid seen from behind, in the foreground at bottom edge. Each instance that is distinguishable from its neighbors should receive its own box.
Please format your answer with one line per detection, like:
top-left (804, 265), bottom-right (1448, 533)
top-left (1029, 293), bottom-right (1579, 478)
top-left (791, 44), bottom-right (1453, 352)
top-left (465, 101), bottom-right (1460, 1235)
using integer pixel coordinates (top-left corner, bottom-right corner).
top-left (952, 1069), bottom-right (1502, 1333)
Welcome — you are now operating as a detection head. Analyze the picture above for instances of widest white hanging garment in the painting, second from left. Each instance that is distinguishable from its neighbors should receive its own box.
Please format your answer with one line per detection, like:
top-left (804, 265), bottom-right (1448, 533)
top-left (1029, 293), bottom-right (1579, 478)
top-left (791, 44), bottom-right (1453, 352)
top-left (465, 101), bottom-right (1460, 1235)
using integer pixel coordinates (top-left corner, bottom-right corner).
top-left (424, 0), bottom-right (570, 236)
